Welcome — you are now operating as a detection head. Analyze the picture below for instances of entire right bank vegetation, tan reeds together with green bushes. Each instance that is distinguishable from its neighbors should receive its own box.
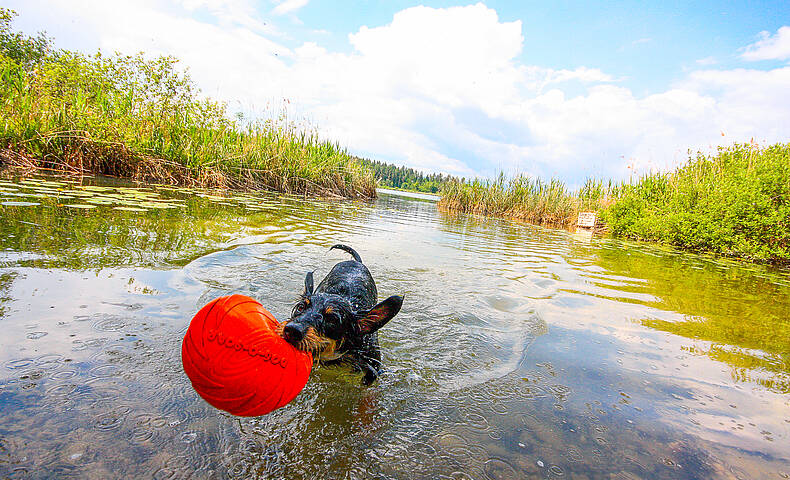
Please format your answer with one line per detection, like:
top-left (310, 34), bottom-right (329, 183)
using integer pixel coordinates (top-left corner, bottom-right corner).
top-left (439, 144), bottom-right (790, 263)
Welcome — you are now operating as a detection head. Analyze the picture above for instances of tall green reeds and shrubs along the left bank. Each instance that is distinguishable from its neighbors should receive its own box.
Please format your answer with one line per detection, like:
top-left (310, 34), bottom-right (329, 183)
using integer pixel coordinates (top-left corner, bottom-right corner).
top-left (0, 9), bottom-right (375, 197)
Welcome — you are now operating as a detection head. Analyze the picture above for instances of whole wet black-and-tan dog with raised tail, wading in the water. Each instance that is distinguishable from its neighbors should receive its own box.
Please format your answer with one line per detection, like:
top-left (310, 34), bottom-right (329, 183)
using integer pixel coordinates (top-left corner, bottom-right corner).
top-left (280, 245), bottom-right (403, 385)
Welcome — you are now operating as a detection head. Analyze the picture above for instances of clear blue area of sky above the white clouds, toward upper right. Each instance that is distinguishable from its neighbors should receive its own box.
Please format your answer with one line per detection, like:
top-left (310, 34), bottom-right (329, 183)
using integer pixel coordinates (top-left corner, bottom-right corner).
top-left (289, 1), bottom-right (790, 88)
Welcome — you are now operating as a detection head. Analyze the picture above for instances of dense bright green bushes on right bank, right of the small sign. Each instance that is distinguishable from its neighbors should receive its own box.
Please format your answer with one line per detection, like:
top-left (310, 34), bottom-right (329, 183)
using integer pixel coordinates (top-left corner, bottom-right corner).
top-left (602, 144), bottom-right (790, 263)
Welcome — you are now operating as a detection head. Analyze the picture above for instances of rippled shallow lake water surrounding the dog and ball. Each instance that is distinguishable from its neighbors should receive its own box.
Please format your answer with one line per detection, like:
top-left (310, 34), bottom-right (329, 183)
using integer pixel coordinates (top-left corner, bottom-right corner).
top-left (0, 179), bottom-right (790, 479)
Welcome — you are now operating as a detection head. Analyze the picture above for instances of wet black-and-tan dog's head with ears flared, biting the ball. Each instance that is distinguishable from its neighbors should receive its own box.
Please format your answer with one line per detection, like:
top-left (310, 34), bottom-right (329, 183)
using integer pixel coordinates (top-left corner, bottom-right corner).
top-left (280, 273), bottom-right (403, 360)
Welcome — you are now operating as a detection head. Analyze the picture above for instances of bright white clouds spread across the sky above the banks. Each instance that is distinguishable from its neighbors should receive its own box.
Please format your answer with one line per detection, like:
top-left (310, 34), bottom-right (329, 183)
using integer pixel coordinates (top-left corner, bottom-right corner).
top-left (6, 0), bottom-right (790, 184)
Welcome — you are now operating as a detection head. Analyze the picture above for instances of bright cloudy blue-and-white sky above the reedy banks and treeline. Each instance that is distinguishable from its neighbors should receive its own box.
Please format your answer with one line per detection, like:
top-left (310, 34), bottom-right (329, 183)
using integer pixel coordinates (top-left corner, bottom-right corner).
top-left (3, 0), bottom-right (790, 186)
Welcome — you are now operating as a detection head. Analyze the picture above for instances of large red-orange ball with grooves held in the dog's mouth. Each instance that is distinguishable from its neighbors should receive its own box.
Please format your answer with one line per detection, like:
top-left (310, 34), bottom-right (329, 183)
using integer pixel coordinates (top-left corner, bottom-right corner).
top-left (181, 295), bottom-right (313, 417)
